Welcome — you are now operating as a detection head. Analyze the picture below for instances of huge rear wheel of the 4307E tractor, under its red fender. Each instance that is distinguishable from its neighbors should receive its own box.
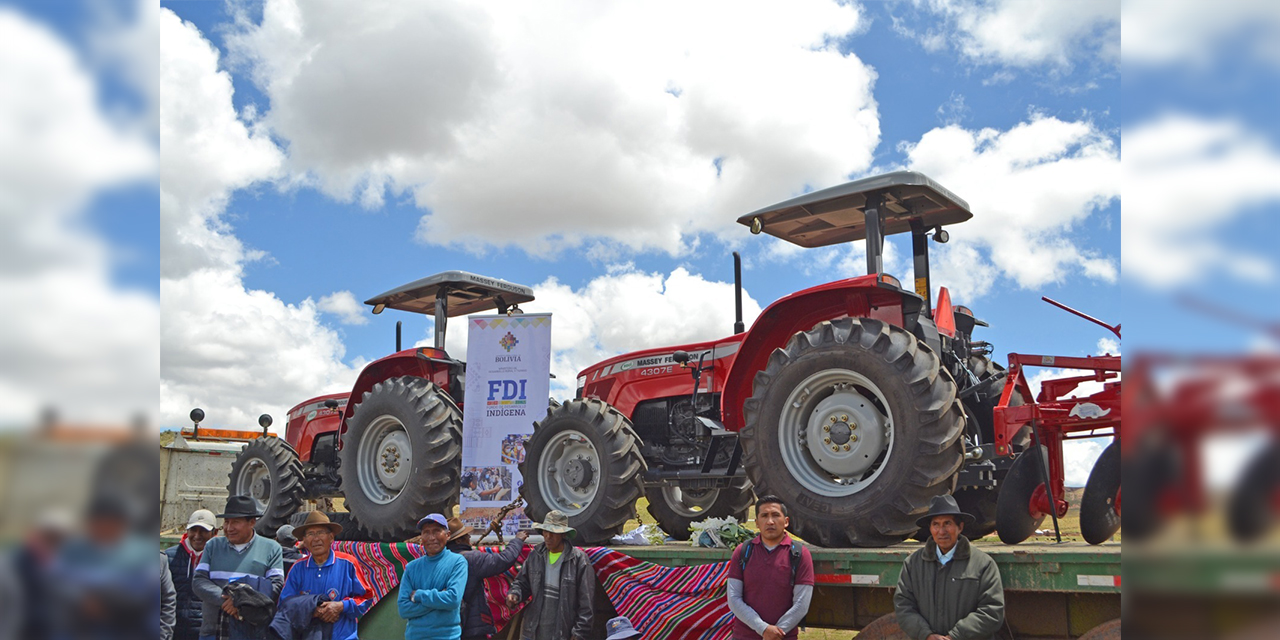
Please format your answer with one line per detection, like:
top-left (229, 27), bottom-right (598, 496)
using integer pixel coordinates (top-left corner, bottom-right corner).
top-left (740, 317), bottom-right (965, 547)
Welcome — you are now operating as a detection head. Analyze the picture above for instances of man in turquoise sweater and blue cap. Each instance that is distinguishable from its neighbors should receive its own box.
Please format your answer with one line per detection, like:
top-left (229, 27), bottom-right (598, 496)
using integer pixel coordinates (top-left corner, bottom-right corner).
top-left (397, 513), bottom-right (467, 640)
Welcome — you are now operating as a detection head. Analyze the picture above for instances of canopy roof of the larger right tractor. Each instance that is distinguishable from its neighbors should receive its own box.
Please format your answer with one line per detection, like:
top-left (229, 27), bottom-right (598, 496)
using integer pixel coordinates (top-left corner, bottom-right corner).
top-left (737, 172), bottom-right (973, 247)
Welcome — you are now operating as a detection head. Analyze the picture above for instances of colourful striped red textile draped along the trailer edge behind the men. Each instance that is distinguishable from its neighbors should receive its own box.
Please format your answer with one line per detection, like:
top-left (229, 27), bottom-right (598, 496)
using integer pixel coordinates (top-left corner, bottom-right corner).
top-left (334, 541), bottom-right (733, 640)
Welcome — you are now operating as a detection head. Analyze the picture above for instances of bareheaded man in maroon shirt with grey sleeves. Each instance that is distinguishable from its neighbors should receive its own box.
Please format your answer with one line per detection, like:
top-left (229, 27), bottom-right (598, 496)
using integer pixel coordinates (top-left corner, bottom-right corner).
top-left (727, 495), bottom-right (813, 640)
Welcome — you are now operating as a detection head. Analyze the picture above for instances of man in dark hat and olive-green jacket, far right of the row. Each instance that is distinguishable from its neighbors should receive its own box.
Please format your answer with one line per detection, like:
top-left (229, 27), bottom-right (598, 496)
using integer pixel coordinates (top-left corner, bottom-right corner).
top-left (893, 495), bottom-right (1005, 640)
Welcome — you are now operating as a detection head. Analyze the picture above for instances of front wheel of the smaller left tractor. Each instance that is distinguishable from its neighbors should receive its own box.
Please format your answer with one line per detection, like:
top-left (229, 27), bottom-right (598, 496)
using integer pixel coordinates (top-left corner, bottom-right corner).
top-left (227, 436), bottom-right (305, 538)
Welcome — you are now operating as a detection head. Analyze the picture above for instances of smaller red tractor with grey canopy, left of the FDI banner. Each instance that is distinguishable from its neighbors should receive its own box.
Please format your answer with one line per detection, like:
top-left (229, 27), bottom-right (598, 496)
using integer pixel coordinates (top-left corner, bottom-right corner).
top-left (228, 271), bottom-right (534, 539)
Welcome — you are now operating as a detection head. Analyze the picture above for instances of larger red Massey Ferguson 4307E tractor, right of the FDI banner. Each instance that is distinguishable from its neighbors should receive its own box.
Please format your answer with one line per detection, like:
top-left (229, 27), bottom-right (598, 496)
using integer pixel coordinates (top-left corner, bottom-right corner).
top-left (521, 172), bottom-right (1025, 547)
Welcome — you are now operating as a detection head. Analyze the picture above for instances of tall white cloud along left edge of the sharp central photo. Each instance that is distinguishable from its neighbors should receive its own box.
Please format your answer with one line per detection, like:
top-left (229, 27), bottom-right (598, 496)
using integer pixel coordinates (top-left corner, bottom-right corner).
top-left (160, 9), bottom-right (357, 430)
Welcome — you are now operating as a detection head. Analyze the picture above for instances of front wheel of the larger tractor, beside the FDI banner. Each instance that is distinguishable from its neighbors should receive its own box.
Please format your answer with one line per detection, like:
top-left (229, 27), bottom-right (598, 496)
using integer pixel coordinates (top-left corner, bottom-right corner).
top-left (520, 398), bottom-right (648, 544)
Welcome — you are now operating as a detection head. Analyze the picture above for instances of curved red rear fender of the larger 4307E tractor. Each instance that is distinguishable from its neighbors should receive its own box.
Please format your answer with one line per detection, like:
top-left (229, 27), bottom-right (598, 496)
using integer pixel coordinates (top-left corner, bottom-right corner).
top-left (721, 275), bottom-right (905, 431)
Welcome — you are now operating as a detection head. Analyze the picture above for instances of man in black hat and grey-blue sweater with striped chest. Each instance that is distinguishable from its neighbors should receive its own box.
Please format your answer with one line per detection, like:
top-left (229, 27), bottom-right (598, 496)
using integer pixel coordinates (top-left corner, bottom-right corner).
top-left (191, 495), bottom-right (284, 640)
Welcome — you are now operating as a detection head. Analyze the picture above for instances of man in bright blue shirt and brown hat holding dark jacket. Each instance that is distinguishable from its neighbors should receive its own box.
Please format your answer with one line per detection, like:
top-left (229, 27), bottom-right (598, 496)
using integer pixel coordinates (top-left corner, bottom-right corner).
top-left (273, 511), bottom-right (371, 640)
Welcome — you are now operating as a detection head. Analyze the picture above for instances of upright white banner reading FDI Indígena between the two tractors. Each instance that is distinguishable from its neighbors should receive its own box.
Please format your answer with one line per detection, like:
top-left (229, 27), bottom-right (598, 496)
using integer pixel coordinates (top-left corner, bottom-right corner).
top-left (460, 314), bottom-right (552, 535)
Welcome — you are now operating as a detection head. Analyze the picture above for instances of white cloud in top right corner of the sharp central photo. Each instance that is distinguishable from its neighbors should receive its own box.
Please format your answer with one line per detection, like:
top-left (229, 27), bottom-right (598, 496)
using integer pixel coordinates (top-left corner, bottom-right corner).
top-left (904, 0), bottom-right (1120, 68)
